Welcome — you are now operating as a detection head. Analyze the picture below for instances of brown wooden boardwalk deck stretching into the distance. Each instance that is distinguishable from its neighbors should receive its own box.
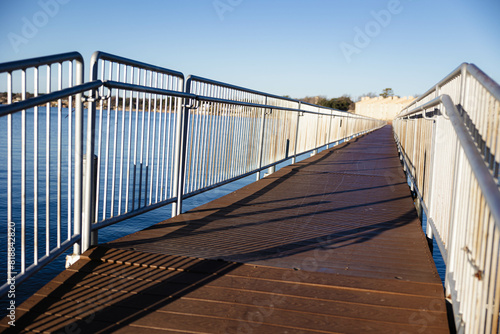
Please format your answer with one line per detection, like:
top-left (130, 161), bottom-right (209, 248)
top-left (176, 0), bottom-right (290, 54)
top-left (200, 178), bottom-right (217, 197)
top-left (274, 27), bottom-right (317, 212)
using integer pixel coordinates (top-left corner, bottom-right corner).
top-left (0, 126), bottom-right (449, 334)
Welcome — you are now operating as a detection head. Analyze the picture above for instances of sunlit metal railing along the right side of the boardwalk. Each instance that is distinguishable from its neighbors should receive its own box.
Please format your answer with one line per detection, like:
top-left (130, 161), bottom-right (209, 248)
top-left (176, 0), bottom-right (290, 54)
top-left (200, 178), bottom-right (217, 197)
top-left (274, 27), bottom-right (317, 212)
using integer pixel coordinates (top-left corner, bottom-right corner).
top-left (393, 64), bottom-right (500, 333)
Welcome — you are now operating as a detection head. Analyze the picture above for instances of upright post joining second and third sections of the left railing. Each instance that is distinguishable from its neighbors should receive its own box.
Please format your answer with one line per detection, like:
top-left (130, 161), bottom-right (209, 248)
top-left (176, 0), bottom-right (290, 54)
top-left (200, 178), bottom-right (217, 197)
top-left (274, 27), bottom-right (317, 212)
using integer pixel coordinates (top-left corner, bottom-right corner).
top-left (172, 77), bottom-right (191, 217)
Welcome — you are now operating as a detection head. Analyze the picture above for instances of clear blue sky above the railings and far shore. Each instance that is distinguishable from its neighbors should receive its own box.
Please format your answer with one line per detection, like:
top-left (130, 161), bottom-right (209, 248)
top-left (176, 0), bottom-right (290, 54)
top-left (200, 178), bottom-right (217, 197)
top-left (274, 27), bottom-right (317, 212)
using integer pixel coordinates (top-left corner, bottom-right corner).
top-left (0, 0), bottom-right (500, 98)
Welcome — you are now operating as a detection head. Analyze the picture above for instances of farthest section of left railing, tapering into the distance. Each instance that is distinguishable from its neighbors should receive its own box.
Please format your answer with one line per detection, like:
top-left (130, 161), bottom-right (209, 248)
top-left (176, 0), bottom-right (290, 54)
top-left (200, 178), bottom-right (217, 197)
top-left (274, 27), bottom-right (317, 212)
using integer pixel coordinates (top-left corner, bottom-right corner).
top-left (178, 76), bottom-right (385, 208)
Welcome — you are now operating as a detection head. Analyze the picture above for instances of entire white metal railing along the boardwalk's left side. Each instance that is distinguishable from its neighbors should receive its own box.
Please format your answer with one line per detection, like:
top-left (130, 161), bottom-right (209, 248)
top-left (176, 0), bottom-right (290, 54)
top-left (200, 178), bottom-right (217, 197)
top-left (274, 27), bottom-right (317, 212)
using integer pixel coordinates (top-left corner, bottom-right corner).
top-left (0, 52), bottom-right (385, 295)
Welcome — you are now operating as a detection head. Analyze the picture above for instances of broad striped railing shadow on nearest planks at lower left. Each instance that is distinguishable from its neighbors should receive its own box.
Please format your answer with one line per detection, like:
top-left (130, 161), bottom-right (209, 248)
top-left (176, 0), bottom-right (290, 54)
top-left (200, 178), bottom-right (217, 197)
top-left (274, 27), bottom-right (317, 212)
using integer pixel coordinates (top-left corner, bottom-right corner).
top-left (5, 252), bottom-right (241, 333)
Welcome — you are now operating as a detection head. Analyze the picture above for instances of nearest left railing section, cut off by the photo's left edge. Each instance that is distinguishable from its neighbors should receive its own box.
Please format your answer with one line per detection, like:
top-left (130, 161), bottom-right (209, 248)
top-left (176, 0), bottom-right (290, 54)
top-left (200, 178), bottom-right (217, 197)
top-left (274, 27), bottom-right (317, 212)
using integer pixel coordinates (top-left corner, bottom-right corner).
top-left (0, 52), bottom-right (99, 294)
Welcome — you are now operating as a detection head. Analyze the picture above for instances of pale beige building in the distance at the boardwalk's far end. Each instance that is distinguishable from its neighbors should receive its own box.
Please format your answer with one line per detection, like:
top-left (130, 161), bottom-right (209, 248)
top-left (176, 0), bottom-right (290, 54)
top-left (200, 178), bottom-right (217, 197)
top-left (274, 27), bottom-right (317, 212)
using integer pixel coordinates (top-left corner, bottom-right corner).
top-left (355, 96), bottom-right (415, 121)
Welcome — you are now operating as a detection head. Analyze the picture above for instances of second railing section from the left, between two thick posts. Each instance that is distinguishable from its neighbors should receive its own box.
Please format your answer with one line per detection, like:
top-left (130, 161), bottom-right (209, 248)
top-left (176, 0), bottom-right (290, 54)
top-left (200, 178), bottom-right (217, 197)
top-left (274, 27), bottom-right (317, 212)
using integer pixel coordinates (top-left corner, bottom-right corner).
top-left (86, 52), bottom-right (188, 236)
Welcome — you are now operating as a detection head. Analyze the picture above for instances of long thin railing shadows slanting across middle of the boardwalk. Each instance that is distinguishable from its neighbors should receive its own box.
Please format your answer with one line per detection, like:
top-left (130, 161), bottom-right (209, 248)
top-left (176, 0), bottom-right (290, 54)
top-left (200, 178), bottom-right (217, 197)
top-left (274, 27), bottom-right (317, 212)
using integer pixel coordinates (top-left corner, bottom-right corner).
top-left (110, 132), bottom-right (418, 261)
